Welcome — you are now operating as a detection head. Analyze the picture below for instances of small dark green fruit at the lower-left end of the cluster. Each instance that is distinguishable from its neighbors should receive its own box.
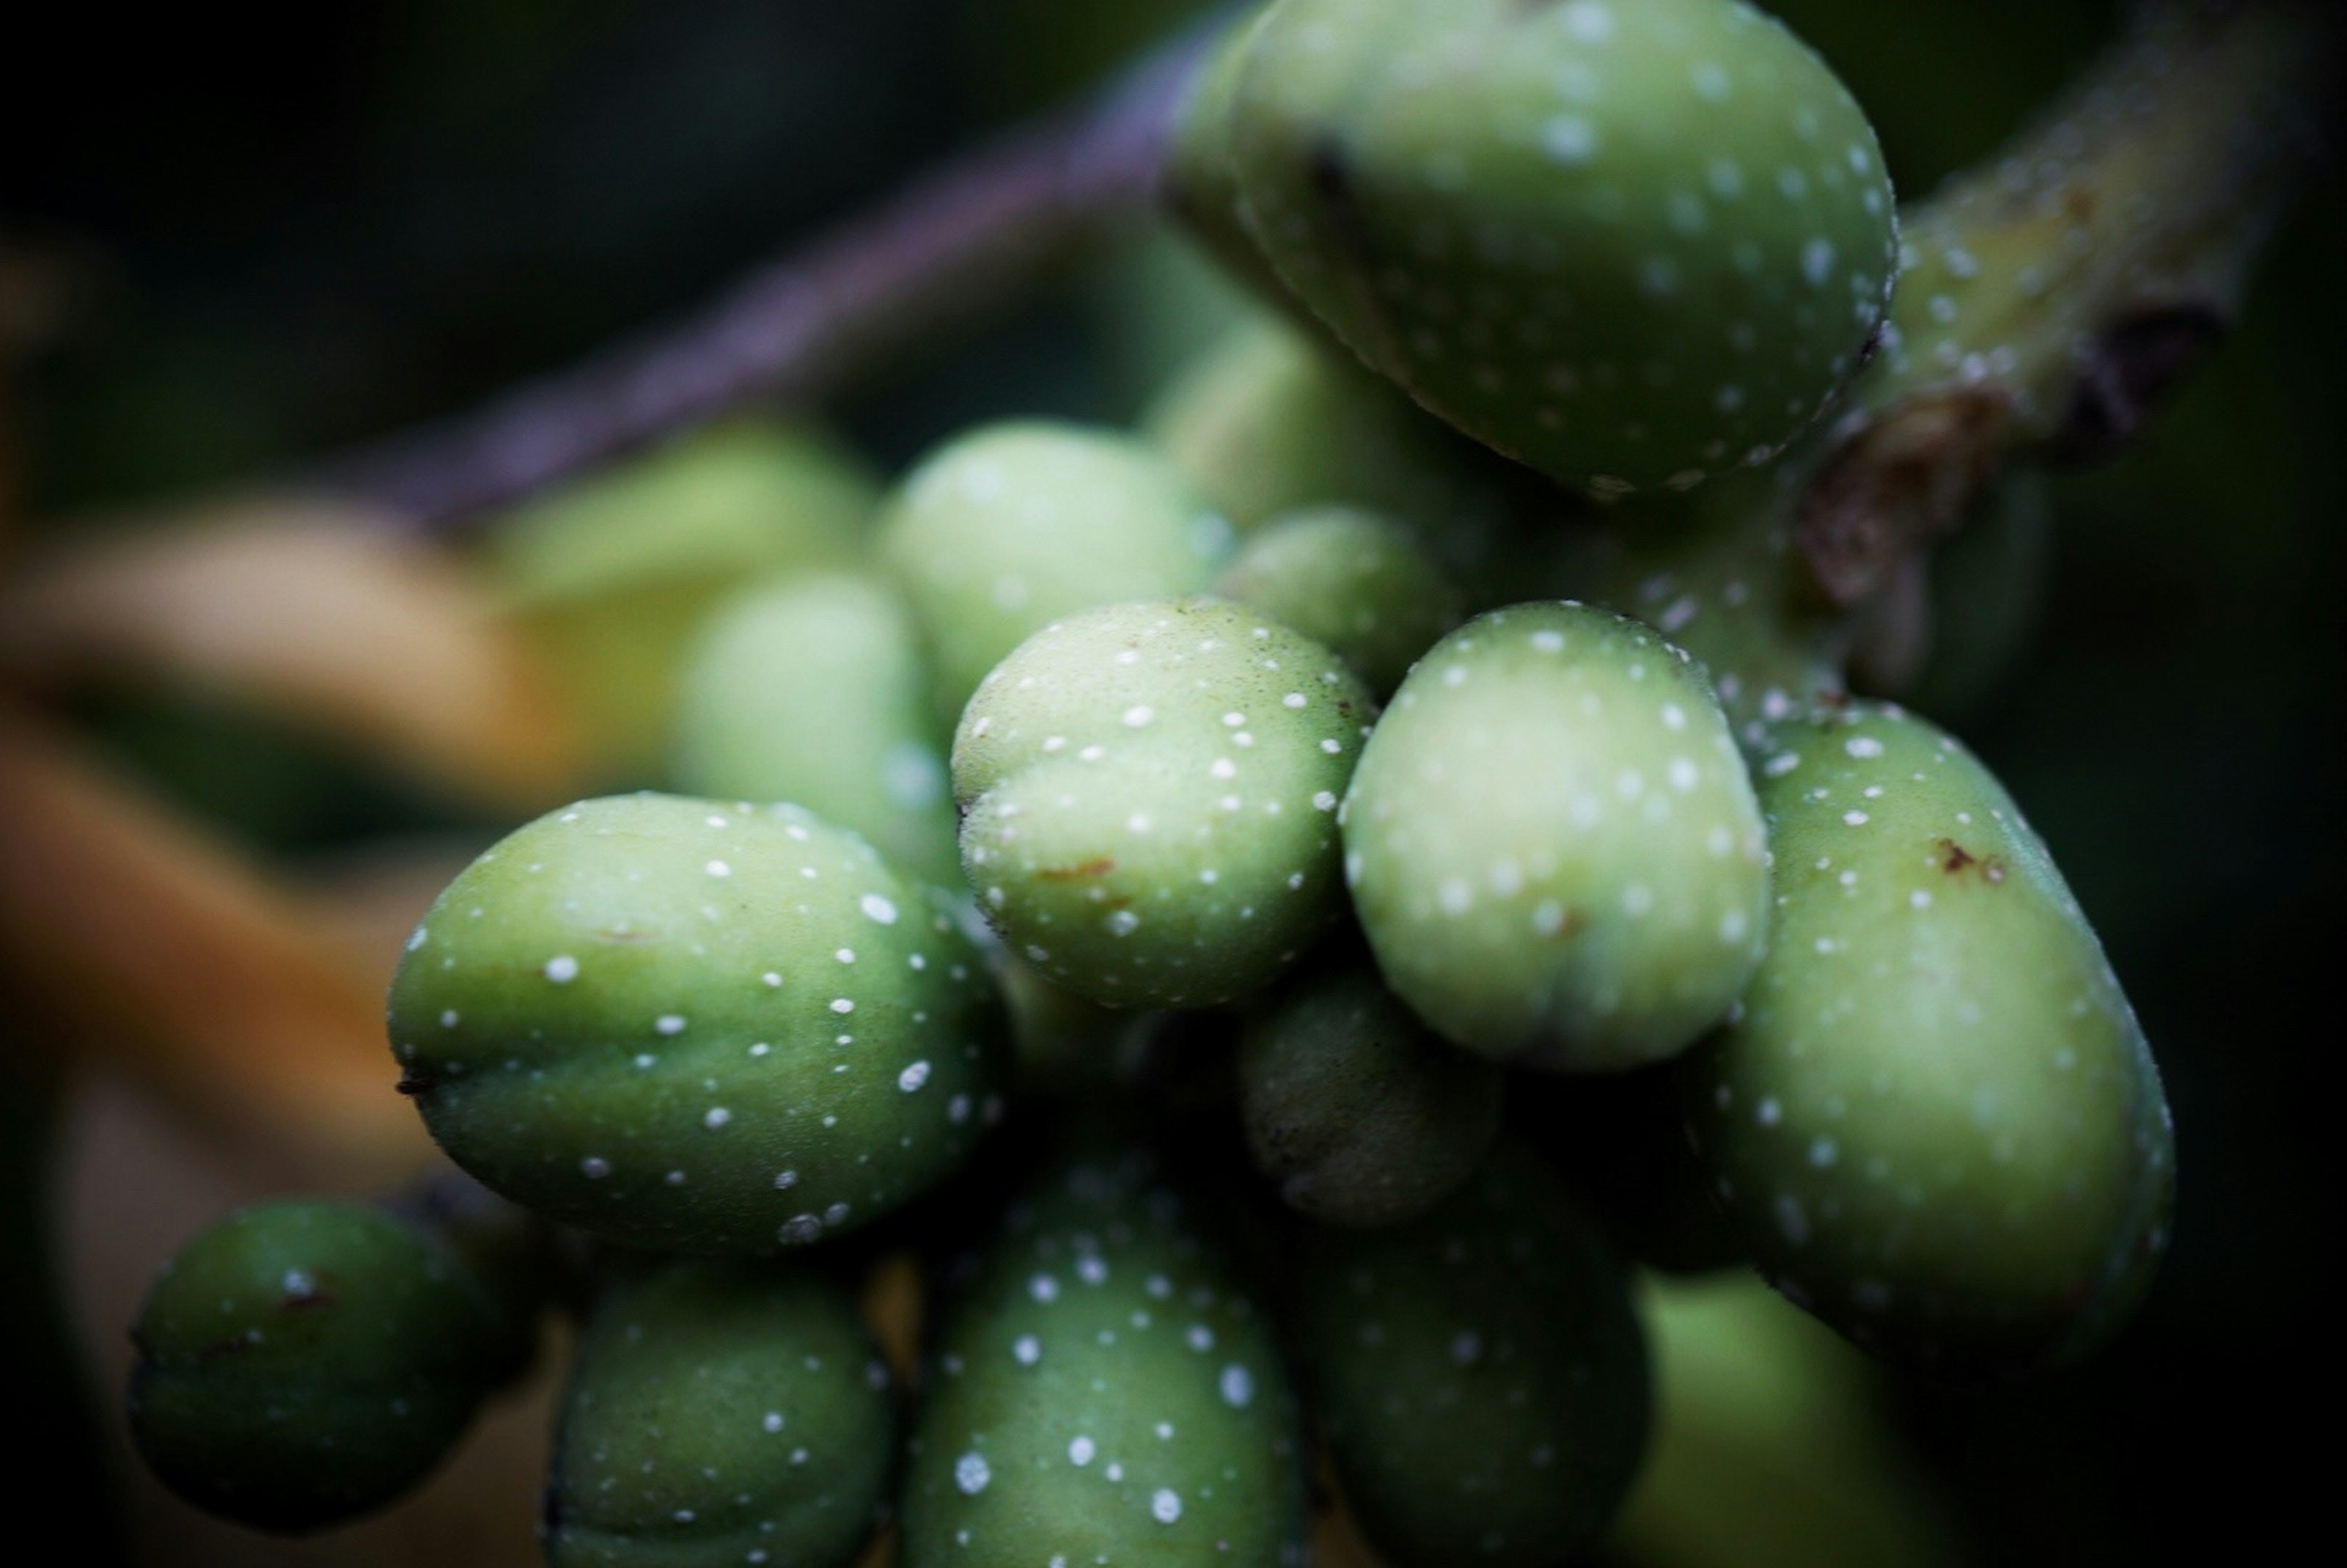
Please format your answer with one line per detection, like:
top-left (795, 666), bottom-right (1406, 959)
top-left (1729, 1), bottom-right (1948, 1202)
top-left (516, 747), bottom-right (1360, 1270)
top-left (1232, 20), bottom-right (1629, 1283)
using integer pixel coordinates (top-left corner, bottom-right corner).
top-left (129, 1200), bottom-right (531, 1531)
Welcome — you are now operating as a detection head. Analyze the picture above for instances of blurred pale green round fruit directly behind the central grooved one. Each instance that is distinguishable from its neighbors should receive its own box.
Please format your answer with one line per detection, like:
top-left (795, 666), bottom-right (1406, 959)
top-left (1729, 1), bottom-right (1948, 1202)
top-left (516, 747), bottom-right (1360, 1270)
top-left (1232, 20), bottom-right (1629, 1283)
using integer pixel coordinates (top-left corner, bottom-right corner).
top-left (880, 422), bottom-right (1230, 723)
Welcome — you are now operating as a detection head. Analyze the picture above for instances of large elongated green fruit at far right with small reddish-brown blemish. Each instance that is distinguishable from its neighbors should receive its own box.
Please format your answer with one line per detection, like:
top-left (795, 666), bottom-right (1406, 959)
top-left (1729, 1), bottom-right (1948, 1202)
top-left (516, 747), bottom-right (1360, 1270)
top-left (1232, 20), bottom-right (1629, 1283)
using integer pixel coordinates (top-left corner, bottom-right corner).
top-left (1680, 706), bottom-right (2173, 1380)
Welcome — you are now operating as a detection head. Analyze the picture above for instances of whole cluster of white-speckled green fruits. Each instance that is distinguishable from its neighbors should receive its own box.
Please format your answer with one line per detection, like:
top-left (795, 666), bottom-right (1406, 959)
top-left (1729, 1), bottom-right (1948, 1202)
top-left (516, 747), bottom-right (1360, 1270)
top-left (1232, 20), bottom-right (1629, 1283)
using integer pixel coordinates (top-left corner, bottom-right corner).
top-left (131, 0), bottom-right (2171, 1568)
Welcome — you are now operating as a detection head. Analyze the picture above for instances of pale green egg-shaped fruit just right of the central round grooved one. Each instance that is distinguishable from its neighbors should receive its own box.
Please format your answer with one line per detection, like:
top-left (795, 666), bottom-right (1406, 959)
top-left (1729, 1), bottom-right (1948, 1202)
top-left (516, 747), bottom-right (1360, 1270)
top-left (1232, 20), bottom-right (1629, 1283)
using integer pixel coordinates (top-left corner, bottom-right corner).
top-left (1342, 601), bottom-right (1768, 1072)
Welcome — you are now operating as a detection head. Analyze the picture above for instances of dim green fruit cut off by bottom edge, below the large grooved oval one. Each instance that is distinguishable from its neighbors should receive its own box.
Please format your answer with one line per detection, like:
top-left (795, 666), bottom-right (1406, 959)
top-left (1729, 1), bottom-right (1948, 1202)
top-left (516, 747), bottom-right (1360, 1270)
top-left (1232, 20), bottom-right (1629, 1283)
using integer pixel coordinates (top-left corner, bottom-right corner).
top-left (545, 1263), bottom-right (897, 1568)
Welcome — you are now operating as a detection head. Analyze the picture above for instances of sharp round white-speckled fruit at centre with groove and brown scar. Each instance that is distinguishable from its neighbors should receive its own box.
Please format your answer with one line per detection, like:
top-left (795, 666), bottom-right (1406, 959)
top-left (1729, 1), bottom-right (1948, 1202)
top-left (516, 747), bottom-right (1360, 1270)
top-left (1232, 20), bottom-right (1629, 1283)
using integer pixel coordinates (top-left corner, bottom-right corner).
top-left (953, 599), bottom-right (1373, 1007)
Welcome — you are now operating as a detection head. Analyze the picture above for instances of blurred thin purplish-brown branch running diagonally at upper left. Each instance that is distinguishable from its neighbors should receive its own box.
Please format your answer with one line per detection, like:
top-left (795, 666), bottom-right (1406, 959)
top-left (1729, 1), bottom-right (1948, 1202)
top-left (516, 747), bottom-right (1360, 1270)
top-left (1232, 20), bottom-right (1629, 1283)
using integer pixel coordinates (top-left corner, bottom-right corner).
top-left (312, 35), bottom-right (1207, 533)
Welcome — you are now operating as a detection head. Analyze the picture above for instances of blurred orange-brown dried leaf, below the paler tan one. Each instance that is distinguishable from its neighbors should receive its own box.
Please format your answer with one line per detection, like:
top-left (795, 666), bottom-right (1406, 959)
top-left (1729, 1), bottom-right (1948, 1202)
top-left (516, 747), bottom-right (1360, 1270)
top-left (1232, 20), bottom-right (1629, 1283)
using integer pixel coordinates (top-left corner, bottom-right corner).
top-left (0, 706), bottom-right (430, 1171)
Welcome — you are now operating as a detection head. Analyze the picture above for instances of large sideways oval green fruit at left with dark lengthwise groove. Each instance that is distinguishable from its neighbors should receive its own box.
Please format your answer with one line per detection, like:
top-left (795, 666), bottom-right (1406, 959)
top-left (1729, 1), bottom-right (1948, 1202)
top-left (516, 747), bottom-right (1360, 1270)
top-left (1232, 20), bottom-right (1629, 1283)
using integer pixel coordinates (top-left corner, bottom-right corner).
top-left (389, 793), bottom-right (1002, 1253)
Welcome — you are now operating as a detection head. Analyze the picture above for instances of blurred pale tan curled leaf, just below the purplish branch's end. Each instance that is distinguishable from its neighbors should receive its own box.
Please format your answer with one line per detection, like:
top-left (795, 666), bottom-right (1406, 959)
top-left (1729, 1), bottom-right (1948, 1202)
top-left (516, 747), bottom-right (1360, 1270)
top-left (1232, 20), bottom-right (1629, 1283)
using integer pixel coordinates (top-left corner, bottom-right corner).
top-left (0, 497), bottom-right (579, 805)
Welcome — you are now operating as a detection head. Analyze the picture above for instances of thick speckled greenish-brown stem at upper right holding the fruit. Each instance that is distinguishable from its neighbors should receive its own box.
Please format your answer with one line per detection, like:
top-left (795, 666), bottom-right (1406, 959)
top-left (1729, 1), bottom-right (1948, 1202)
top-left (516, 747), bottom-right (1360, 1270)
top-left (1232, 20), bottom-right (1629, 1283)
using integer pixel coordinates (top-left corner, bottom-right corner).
top-left (1800, 0), bottom-right (2342, 606)
